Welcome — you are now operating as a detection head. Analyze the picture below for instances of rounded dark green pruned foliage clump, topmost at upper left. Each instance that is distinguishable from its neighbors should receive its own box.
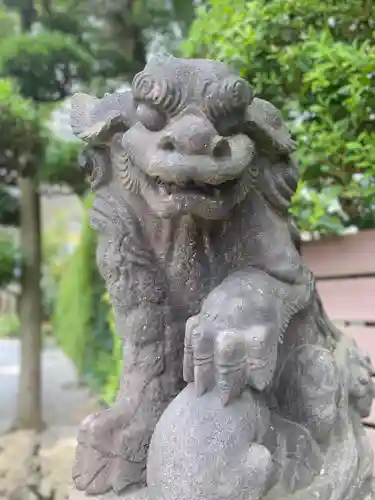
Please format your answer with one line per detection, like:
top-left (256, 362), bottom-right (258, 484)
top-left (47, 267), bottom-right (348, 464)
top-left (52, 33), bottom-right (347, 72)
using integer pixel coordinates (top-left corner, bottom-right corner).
top-left (0, 31), bottom-right (94, 103)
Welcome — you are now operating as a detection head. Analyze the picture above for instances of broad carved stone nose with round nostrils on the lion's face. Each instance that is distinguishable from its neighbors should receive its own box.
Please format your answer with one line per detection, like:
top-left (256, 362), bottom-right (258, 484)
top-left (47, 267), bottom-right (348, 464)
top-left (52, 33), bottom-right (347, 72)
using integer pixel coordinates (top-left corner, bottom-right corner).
top-left (158, 116), bottom-right (230, 159)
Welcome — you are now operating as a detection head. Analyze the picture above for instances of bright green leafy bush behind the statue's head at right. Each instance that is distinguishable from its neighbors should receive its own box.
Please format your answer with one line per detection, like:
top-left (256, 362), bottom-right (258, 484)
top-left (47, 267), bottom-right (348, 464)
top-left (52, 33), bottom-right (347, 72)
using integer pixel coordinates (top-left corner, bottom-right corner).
top-left (187, 0), bottom-right (375, 233)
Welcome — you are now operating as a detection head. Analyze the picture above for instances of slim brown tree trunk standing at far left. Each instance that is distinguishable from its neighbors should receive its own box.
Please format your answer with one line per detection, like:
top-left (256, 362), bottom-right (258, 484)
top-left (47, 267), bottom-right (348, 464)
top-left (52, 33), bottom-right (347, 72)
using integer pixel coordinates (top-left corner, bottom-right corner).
top-left (15, 177), bottom-right (43, 430)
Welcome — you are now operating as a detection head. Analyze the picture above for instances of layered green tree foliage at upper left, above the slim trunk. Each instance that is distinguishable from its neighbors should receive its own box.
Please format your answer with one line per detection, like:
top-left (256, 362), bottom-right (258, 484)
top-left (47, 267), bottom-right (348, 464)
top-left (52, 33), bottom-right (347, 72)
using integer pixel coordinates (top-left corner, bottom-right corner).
top-left (0, 1), bottom-right (95, 189)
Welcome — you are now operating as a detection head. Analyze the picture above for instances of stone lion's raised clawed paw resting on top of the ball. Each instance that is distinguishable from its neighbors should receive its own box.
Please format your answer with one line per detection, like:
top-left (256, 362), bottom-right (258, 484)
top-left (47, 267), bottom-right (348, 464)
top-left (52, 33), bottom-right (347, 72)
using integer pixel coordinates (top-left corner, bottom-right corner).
top-left (183, 313), bottom-right (278, 405)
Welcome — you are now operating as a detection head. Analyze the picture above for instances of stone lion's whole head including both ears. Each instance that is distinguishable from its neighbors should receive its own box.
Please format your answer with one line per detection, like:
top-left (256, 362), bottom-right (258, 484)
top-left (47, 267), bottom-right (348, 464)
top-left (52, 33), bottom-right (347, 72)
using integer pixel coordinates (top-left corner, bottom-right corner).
top-left (71, 57), bottom-right (295, 219)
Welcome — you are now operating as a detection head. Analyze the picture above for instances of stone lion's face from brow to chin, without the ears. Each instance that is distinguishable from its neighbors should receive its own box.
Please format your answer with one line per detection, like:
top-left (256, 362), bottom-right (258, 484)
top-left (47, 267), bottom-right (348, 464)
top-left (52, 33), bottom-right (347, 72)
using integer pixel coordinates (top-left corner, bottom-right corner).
top-left (113, 59), bottom-right (255, 218)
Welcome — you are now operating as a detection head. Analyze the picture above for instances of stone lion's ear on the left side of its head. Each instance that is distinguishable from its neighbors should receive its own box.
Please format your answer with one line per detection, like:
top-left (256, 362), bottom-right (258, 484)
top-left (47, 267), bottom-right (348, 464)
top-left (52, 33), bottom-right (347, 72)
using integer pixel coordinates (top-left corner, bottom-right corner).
top-left (70, 90), bottom-right (136, 145)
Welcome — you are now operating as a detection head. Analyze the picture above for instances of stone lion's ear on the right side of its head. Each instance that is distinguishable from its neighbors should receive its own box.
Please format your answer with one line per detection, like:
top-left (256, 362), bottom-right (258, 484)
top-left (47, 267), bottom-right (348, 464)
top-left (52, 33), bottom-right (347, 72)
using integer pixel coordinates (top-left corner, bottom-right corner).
top-left (245, 97), bottom-right (296, 155)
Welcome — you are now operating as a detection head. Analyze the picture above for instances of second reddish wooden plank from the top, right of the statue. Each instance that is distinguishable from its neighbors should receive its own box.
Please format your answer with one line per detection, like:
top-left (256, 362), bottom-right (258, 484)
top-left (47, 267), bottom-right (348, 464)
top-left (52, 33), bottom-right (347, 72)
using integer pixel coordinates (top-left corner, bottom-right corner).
top-left (317, 280), bottom-right (375, 322)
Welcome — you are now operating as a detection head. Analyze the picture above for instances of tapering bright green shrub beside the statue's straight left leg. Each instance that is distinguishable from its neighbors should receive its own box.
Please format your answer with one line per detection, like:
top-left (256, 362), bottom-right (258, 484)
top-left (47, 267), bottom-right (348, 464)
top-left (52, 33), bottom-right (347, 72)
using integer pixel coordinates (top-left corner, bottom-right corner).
top-left (53, 195), bottom-right (113, 393)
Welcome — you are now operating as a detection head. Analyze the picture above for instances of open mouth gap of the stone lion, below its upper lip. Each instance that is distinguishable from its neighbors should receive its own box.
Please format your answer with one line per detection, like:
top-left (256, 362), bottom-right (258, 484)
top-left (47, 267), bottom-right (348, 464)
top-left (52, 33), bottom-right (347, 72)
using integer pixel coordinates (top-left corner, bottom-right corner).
top-left (153, 177), bottom-right (238, 198)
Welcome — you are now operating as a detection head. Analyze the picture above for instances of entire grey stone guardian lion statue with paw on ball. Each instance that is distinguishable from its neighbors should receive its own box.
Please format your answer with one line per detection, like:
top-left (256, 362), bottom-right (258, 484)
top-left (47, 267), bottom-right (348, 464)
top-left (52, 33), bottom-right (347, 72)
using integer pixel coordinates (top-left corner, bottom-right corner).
top-left (72, 57), bottom-right (374, 500)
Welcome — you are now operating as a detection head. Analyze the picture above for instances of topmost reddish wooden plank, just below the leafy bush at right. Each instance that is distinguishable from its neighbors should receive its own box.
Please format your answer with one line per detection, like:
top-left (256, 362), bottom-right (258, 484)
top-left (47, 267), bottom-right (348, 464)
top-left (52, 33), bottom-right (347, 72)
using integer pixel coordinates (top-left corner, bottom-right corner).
top-left (302, 229), bottom-right (375, 278)
